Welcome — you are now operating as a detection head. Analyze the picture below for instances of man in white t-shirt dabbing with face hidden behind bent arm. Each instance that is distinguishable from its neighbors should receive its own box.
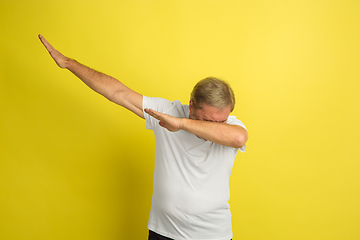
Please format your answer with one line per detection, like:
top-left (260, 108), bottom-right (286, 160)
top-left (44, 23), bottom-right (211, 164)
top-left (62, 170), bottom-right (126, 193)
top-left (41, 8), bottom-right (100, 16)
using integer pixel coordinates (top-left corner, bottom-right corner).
top-left (39, 35), bottom-right (248, 240)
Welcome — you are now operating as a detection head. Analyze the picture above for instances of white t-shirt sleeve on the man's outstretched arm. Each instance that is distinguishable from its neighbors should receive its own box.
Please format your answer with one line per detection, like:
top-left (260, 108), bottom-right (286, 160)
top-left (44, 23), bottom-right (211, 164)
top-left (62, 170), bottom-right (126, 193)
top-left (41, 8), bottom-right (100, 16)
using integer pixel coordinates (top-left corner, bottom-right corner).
top-left (143, 96), bottom-right (173, 129)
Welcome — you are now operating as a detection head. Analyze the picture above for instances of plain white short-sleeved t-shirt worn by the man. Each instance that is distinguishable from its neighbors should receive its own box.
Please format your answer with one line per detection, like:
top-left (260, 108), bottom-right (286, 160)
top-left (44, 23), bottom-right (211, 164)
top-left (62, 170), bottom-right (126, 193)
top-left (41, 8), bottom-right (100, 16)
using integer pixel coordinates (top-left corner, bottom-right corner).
top-left (143, 96), bottom-right (246, 240)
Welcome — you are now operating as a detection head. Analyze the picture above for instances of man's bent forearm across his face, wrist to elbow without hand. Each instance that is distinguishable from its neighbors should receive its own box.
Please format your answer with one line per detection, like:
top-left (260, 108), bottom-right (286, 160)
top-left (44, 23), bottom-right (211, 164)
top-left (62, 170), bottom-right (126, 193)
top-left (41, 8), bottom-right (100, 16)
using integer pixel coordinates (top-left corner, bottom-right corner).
top-left (181, 118), bottom-right (248, 148)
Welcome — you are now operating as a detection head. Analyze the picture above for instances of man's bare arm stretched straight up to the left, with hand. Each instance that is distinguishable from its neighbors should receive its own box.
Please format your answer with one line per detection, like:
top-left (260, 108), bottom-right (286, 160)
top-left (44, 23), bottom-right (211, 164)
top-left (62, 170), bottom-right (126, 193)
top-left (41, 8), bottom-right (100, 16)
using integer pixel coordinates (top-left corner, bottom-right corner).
top-left (39, 35), bottom-right (144, 118)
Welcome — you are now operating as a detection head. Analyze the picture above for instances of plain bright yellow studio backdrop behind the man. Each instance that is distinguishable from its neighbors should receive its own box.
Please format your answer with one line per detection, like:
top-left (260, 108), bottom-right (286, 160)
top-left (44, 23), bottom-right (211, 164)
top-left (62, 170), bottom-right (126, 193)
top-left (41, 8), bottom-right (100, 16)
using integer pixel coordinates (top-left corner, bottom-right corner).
top-left (0, 0), bottom-right (360, 240)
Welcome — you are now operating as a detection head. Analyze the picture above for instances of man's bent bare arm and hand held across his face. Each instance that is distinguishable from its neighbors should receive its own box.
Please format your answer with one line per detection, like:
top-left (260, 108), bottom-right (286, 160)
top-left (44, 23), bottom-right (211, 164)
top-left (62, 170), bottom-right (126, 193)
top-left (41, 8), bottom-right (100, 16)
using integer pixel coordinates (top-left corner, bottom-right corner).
top-left (145, 109), bottom-right (248, 148)
